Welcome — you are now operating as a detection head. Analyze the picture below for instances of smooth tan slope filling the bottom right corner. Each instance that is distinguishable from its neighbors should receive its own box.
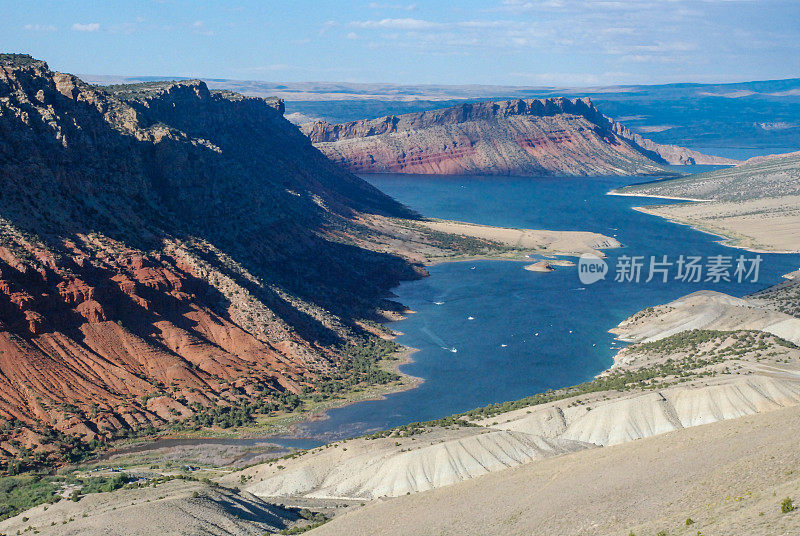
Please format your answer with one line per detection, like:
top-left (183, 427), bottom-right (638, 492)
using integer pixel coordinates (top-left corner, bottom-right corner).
top-left (311, 406), bottom-right (800, 536)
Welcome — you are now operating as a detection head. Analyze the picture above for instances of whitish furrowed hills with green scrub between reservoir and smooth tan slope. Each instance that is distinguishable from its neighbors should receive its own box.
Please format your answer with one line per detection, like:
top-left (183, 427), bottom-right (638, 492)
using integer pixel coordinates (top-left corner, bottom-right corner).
top-left (227, 288), bottom-right (800, 500)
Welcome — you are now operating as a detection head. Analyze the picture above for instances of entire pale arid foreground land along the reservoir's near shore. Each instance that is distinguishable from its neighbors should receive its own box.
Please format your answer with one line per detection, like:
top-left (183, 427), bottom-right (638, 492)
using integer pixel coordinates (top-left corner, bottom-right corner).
top-left (0, 279), bottom-right (800, 536)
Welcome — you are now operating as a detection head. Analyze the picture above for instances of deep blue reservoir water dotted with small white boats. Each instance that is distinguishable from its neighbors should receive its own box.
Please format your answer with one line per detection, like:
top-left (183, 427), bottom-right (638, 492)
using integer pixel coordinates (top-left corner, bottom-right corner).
top-left (298, 175), bottom-right (800, 441)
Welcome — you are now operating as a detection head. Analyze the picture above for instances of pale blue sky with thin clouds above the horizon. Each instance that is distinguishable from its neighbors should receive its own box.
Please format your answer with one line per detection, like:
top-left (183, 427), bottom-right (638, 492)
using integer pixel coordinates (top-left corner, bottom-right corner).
top-left (0, 0), bottom-right (800, 86)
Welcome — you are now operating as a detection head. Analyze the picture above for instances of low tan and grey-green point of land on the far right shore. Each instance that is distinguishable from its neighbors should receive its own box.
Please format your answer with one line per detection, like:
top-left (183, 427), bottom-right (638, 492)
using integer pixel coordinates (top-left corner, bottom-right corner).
top-left (613, 153), bottom-right (800, 253)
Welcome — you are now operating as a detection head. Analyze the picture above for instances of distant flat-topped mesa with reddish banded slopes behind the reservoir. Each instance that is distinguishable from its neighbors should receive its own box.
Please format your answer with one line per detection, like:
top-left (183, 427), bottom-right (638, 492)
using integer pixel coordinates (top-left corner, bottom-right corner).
top-left (302, 98), bottom-right (733, 175)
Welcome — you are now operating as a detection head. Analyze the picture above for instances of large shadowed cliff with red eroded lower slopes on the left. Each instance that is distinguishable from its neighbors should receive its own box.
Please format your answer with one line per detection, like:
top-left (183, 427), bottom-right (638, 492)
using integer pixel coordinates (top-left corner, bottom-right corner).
top-left (0, 55), bottom-right (438, 465)
